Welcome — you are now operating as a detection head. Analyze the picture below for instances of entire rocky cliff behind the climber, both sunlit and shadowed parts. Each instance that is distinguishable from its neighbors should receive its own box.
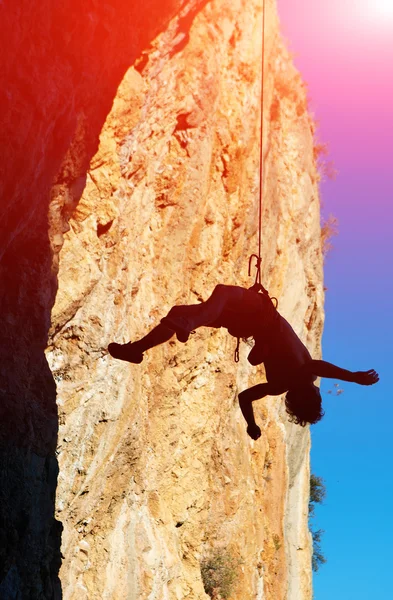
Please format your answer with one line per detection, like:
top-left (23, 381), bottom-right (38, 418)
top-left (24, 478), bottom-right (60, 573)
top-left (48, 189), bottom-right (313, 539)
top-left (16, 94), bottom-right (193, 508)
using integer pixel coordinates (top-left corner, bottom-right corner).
top-left (0, 0), bottom-right (323, 600)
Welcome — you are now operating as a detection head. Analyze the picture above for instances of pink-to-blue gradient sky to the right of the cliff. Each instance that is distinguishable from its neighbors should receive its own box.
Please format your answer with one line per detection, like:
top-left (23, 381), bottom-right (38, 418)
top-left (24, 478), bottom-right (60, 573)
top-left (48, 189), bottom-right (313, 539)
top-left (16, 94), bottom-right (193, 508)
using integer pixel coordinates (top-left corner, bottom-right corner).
top-left (277, 0), bottom-right (393, 600)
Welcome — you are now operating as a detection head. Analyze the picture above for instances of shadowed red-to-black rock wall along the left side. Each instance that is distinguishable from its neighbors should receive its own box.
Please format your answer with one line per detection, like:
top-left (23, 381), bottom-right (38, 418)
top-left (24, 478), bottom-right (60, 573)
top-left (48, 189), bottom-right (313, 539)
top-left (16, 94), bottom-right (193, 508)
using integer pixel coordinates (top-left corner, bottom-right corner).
top-left (0, 0), bottom-right (206, 600)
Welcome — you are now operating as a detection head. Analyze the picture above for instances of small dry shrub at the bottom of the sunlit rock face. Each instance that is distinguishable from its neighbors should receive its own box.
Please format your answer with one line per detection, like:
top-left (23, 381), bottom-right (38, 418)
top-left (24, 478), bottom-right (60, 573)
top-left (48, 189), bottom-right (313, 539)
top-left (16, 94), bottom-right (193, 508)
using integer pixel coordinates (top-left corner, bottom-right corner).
top-left (201, 550), bottom-right (240, 600)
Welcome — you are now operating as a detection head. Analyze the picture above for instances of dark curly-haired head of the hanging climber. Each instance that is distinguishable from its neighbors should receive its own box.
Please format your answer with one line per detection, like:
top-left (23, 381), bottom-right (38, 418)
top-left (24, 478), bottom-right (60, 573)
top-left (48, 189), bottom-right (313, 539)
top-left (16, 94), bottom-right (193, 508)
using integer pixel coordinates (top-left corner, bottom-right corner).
top-left (285, 383), bottom-right (325, 427)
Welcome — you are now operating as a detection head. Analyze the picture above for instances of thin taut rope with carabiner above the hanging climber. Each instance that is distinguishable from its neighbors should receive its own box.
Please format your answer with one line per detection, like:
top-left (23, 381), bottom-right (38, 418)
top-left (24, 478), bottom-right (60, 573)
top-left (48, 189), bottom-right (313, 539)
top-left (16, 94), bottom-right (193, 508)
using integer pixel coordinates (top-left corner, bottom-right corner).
top-left (248, 0), bottom-right (268, 293)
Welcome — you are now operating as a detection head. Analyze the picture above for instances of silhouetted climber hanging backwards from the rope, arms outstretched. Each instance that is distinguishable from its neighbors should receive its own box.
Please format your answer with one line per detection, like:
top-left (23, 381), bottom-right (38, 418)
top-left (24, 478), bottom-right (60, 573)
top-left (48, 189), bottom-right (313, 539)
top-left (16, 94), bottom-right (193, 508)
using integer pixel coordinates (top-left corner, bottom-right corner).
top-left (108, 284), bottom-right (379, 440)
